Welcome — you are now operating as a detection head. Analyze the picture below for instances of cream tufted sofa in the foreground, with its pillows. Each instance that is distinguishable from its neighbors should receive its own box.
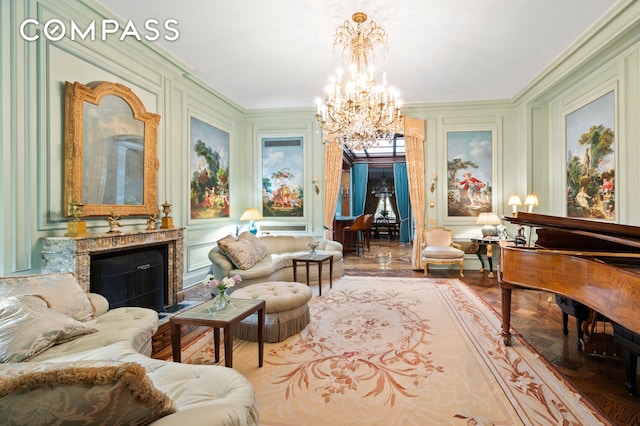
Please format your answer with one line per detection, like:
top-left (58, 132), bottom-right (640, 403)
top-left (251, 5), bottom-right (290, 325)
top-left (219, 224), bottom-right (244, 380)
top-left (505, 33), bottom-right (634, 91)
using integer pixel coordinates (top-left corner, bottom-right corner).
top-left (0, 273), bottom-right (258, 426)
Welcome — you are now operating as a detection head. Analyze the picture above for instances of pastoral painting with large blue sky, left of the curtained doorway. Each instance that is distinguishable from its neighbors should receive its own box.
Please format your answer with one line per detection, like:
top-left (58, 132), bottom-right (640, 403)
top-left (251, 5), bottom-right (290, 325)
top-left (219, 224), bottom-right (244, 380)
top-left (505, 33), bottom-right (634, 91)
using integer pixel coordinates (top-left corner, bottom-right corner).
top-left (262, 137), bottom-right (304, 217)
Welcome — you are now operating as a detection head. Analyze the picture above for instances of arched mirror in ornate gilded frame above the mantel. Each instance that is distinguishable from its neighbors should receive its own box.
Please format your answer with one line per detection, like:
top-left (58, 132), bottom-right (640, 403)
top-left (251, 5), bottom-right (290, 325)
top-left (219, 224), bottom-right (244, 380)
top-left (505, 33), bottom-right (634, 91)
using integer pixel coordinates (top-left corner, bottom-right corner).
top-left (64, 82), bottom-right (160, 216)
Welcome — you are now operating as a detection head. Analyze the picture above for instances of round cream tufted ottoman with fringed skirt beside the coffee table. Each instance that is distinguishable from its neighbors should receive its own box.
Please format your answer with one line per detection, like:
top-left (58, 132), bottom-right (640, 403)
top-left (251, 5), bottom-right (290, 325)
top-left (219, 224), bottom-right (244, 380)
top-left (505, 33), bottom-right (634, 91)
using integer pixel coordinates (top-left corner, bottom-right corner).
top-left (231, 281), bottom-right (312, 343)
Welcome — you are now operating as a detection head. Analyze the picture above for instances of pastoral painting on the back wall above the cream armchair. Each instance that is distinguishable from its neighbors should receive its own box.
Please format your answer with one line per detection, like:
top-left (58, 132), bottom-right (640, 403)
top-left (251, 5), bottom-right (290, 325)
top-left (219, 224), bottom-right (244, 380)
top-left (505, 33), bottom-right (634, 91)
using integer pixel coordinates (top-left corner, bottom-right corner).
top-left (446, 130), bottom-right (493, 217)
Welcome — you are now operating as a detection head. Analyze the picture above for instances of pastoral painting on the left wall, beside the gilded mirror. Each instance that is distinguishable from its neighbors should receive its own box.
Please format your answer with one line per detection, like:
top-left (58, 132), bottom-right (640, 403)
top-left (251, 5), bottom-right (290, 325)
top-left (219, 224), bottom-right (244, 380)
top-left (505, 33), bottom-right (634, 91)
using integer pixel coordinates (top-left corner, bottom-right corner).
top-left (189, 117), bottom-right (229, 219)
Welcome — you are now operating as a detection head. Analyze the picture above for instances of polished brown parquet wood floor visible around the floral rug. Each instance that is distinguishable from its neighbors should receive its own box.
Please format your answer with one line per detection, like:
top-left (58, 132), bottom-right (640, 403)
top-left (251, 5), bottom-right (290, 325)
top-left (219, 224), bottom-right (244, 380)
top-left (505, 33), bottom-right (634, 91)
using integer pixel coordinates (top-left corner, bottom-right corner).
top-left (160, 238), bottom-right (640, 425)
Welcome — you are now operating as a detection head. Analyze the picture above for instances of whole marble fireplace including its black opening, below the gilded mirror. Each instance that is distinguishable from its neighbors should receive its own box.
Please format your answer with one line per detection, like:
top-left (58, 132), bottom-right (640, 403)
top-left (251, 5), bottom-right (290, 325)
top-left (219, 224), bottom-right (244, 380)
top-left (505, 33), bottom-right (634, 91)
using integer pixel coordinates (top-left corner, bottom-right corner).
top-left (41, 228), bottom-right (184, 310)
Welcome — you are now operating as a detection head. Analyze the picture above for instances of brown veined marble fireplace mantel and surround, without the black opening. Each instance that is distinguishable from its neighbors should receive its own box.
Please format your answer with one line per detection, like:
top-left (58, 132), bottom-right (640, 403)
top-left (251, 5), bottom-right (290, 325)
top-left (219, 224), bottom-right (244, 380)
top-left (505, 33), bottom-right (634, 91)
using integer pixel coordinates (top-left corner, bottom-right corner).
top-left (41, 228), bottom-right (184, 305)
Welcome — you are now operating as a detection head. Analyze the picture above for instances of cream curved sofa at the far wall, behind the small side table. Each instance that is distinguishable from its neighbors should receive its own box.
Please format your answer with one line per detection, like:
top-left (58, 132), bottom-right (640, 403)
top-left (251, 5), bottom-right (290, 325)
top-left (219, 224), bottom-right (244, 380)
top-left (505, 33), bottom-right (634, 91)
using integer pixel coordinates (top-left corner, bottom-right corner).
top-left (209, 232), bottom-right (344, 289)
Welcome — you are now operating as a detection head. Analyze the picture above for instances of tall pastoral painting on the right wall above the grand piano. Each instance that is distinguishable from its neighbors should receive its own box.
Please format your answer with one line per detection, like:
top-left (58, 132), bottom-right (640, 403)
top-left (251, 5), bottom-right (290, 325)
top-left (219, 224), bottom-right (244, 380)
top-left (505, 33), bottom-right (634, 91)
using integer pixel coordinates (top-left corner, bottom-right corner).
top-left (565, 90), bottom-right (616, 221)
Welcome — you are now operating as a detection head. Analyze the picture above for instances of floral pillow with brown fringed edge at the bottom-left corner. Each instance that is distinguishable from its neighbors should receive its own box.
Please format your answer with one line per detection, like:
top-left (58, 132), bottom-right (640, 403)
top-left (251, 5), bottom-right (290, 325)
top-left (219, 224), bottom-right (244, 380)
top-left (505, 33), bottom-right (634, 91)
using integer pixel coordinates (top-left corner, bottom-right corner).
top-left (0, 361), bottom-right (176, 425)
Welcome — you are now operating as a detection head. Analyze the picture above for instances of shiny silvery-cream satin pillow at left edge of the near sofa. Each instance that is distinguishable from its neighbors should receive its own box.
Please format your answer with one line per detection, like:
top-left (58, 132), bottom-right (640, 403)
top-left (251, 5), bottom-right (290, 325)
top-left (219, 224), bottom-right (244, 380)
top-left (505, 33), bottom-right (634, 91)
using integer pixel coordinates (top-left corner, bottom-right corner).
top-left (0, 295), bottom-right (98, 363)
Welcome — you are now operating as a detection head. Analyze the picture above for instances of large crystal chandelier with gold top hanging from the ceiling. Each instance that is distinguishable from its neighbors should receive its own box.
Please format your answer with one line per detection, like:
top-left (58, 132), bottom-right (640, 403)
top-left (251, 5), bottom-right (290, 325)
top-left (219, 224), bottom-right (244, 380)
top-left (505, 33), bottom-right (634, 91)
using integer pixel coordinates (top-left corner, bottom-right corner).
top-left (316, 12), bottom-right (402, 151)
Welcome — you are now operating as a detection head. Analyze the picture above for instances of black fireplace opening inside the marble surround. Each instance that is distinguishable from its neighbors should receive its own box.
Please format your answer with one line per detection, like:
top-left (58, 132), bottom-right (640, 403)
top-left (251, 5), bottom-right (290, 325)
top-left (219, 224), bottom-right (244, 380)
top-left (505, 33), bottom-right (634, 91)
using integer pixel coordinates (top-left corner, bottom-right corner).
top-left (90, 245), bottom-right (168, 312)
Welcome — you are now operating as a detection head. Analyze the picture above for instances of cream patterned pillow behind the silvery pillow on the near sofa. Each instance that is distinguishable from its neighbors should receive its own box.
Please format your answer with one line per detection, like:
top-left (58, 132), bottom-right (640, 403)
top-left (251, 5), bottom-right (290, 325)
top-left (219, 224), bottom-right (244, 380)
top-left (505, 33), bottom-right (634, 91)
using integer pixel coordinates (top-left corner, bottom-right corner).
top-left (0, 272), bottom-right (95, 321)
